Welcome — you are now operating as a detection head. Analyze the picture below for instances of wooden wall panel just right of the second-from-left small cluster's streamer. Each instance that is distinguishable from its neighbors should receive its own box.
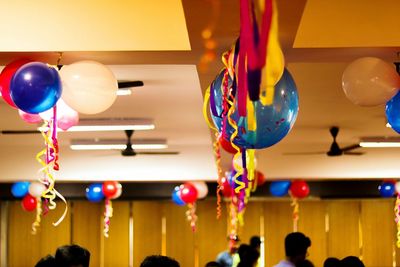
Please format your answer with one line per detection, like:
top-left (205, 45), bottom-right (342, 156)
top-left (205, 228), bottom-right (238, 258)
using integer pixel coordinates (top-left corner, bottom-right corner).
top-left (102, 201), bottom-right (130, 267)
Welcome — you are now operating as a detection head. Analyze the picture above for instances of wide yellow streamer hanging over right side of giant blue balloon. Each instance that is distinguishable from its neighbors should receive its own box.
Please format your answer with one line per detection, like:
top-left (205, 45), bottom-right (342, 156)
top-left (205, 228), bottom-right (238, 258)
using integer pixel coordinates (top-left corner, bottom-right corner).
top-left (259, 0), bottom-right (285, 106)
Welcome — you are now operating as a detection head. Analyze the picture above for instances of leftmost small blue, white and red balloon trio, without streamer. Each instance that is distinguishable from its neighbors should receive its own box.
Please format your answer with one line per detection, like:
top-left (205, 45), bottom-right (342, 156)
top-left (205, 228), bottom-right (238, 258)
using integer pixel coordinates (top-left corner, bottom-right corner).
top-left (11, 181), bottom-right (46, 211)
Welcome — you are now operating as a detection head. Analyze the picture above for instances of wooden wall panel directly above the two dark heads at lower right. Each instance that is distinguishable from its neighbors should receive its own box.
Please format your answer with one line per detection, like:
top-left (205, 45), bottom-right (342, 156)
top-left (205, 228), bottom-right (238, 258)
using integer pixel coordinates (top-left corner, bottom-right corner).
top-left (327, 200), bottom-right (360, 258)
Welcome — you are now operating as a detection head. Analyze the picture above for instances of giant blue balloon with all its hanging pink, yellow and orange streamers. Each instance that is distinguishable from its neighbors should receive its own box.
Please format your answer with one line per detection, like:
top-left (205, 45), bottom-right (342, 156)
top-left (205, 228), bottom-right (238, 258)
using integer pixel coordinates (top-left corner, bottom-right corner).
top-left (203, 0), bottom-right (299, 239)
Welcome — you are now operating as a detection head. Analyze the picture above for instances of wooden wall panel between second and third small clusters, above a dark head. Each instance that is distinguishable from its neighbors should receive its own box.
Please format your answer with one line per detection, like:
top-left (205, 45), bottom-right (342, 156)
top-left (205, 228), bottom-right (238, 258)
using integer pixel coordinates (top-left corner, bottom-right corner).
top-left (132, 201), bottom-right (162, 267)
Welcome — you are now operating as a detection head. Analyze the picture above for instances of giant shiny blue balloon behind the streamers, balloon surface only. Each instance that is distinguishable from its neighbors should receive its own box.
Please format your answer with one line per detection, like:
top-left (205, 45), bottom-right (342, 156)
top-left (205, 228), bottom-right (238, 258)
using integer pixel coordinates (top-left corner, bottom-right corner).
top-left (210, 69), bottom-right (299, 149)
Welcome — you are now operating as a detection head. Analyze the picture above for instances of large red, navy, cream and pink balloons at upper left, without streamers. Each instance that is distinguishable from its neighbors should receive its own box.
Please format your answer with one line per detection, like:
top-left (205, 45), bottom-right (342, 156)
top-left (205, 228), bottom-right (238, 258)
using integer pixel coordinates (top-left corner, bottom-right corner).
top-left (0, 59), bottom-right (118, 130)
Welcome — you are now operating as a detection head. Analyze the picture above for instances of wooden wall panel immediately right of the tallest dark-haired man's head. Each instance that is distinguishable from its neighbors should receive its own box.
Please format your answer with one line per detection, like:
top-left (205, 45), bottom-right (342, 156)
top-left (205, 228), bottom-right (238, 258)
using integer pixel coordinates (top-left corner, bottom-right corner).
top-left (298, 201), bottom-right (327, 266)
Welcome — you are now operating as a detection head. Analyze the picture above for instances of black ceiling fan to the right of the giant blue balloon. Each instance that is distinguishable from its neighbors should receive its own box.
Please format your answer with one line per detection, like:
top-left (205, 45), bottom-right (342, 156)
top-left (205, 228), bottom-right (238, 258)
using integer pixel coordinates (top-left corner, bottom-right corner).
top-left (285, 126), bottom-right (364, 157)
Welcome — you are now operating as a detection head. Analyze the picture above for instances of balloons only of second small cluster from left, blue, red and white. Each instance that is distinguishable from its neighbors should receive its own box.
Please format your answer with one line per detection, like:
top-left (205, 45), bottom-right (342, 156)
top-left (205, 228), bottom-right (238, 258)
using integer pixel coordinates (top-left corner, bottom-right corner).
top-left (86, 181), bottom-right (122, 202)
